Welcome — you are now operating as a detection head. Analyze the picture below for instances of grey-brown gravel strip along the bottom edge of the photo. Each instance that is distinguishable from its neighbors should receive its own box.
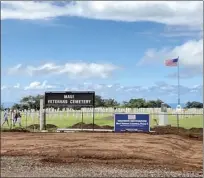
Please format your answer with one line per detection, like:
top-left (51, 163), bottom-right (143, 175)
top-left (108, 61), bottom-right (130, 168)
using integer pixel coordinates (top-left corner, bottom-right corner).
top-left (1, 157), bottom-right (203, 177)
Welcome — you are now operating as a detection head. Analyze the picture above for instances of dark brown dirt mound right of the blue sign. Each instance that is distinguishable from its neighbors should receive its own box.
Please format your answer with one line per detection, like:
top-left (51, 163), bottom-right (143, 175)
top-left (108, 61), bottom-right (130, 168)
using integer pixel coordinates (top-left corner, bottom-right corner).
top-left (151, 126), bottom-right (203, 140)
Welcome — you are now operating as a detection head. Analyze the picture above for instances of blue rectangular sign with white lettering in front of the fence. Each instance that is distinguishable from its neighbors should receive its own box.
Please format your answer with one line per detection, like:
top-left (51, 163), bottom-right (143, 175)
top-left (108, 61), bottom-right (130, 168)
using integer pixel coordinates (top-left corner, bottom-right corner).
top-left (114, 114), bottom-right (150, 132)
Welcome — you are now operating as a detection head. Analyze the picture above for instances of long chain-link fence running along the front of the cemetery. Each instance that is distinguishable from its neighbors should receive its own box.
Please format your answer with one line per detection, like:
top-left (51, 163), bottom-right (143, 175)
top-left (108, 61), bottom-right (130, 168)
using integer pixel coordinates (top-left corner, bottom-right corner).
top-left (1, 111), bottom-right (203, 132)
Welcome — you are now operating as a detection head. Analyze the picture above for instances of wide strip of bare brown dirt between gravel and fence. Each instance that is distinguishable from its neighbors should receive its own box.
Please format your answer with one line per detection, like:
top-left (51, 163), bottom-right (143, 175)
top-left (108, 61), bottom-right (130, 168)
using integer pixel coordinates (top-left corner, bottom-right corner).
top-left (1, 132), bottom-right (202, 171)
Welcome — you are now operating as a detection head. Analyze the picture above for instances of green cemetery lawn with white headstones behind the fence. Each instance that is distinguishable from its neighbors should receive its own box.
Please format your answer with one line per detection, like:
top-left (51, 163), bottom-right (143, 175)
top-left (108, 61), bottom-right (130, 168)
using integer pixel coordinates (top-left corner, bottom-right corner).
top-left (3, 113), bottom-right (203, 129)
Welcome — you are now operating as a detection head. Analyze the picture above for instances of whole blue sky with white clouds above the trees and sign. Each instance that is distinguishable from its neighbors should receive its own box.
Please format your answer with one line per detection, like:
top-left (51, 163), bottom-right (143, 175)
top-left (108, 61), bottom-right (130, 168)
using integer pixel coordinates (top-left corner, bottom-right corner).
top-left (1, 1), bottom-right (203, 103)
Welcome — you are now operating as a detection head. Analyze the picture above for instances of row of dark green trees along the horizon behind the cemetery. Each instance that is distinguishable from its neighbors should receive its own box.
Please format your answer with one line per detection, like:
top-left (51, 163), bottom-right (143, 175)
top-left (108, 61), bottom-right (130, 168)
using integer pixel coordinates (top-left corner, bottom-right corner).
top-left (1, 95), bottom-right (203, 110)
